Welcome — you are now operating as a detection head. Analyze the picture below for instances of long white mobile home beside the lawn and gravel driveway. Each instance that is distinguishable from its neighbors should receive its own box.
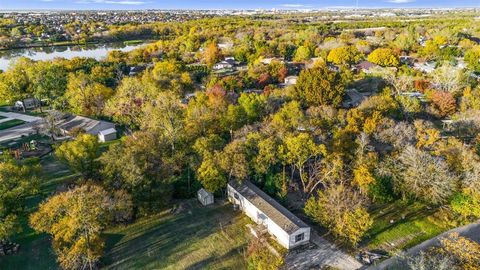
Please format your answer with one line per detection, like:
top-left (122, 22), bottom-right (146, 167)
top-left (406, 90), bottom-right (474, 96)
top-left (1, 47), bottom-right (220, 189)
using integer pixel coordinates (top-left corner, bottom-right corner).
top-left (227, 181), bottom-right (310, 249)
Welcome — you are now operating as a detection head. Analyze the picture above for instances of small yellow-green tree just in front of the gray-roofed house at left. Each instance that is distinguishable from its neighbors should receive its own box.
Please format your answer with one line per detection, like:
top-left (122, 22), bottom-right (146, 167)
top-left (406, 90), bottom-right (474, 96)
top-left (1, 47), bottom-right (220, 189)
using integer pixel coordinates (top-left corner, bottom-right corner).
top-left (55, 134), bottom-right (100, 179)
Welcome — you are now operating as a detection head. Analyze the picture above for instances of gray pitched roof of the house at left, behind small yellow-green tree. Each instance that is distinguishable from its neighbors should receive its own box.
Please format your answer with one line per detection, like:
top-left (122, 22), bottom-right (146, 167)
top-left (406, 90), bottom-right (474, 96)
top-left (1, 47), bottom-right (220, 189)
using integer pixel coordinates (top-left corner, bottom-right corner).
top-left (58, 115), bottom-right (115, 135)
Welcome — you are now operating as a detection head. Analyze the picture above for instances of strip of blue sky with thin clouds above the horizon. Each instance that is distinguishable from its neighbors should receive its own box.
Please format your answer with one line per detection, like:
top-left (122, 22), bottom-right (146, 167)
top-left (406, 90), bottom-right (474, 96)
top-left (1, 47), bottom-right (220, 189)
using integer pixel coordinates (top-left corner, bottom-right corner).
top-left (0, 0), bottom-right (480, 10)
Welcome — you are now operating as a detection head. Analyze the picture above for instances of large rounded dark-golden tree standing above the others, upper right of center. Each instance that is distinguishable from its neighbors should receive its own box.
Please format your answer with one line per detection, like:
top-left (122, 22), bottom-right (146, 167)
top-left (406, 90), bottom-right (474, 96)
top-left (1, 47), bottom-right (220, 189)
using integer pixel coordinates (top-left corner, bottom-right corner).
top-left (295, 65), bottom-right (345, 106)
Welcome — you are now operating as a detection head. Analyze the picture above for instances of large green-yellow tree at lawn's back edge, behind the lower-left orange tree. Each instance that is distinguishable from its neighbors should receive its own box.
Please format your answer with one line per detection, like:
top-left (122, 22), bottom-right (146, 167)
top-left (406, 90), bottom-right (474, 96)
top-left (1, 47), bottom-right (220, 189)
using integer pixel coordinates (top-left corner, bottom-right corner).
top-left (99, 131), bottom-right (175, 214)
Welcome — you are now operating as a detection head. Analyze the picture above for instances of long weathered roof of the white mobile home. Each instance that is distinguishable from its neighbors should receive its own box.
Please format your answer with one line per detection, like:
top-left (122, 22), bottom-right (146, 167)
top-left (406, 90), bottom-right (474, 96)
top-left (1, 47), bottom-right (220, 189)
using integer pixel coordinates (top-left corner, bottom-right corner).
top-left (229, 181), bottom-right (308, 233)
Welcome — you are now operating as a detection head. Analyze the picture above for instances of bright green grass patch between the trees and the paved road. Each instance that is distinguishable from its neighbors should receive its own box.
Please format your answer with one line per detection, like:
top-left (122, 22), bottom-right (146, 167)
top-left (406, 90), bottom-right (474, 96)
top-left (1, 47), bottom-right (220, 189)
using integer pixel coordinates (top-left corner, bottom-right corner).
top-left (361, 201), bottom-right (453, 251)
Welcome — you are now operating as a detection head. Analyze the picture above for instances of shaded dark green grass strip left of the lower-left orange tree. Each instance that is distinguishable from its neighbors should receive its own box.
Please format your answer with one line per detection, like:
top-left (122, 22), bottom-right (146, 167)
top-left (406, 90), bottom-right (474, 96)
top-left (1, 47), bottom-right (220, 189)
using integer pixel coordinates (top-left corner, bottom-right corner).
top-left (0, 156), bottom-right (76, 270)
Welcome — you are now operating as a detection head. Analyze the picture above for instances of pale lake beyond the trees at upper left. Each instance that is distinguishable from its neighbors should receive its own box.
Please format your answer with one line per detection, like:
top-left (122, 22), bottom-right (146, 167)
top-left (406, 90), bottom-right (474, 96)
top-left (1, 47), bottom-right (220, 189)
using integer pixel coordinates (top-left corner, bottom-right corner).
top-left (0, 43), bottom-right (145, 70)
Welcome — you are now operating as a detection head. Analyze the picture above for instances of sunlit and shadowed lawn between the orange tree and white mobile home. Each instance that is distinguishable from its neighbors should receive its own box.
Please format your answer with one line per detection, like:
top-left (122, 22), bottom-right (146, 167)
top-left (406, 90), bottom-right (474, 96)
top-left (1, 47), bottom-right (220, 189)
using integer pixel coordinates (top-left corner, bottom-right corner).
top-left (103, 200), bottom-right (249, 270)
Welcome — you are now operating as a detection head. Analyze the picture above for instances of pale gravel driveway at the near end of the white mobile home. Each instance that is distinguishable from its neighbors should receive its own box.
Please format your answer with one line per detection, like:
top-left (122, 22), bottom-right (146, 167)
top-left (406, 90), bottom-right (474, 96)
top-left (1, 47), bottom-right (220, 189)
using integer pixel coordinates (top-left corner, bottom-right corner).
top-left (284, 230), bottom-right (362, 270)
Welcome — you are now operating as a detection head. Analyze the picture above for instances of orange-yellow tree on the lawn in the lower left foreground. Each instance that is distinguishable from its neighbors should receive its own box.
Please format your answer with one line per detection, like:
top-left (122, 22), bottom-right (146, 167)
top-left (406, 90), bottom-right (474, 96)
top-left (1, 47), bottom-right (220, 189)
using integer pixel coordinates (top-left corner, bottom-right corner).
top-left (30, 184), bottom-right (128, 269)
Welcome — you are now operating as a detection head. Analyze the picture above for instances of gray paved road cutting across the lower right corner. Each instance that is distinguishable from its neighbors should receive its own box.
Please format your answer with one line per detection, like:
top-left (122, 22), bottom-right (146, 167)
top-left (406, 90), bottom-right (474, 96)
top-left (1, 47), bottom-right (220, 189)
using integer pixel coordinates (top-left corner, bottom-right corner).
top-left (368, 220), bottom-right (480, 270)
